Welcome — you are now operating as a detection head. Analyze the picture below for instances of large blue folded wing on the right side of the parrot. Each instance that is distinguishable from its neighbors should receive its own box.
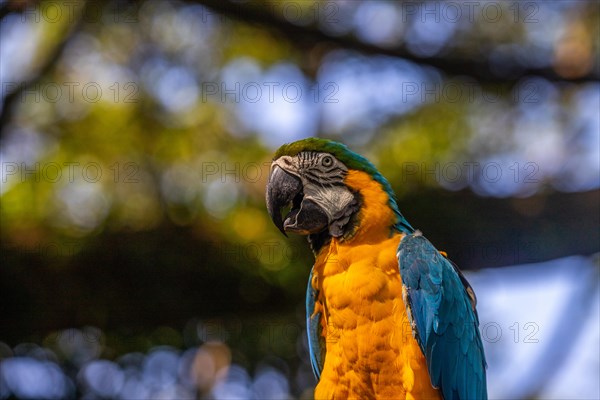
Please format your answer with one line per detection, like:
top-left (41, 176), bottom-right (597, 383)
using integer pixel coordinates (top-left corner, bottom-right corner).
top-left (398, 234), bottom-right (487, 400)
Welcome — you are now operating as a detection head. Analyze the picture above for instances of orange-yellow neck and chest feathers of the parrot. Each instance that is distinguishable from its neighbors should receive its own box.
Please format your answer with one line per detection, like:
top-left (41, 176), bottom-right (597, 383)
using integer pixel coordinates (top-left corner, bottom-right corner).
top-left (311, 171), bottom-right (439, 399)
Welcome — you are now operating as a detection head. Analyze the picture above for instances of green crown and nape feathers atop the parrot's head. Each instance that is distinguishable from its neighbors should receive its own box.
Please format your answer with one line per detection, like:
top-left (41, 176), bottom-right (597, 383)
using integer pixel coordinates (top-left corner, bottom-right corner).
top-left (273, 138), bottom-right (414, 233)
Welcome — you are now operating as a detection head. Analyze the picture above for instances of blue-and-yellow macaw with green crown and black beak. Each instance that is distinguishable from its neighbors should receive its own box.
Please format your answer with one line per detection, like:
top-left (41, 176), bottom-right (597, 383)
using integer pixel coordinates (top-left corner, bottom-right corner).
top-left (266, 138), bottom-right (487, 400)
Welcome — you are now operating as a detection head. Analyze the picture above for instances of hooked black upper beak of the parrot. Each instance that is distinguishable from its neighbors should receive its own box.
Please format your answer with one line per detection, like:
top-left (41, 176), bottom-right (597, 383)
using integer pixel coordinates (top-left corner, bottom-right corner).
top-left (266, 165), bottom-right (302, 236)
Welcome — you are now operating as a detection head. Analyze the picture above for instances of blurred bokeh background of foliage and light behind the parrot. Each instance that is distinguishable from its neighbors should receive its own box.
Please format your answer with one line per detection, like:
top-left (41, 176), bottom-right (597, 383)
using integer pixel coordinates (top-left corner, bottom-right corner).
top-left (0, 0), bottom-right (600, 399)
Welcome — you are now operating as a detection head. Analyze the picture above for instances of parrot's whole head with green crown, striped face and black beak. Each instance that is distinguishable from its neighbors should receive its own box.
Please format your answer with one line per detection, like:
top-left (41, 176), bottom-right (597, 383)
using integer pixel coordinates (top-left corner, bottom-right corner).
top-left (266, 138), bottom-right (413, 247)
